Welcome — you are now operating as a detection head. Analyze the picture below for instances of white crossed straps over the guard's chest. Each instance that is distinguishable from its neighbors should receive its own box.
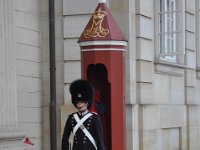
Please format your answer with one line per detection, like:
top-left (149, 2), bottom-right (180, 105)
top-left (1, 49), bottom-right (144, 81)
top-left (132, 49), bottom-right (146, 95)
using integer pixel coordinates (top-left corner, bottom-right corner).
top-left (73, 113), bottom-right (97, 149)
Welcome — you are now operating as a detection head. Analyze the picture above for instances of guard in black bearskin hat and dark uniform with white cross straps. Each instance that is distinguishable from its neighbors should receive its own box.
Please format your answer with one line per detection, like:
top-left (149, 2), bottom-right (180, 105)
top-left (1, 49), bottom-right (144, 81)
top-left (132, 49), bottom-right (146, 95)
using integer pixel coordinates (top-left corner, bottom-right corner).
top-left (62, 79), bottom-right (105, 150)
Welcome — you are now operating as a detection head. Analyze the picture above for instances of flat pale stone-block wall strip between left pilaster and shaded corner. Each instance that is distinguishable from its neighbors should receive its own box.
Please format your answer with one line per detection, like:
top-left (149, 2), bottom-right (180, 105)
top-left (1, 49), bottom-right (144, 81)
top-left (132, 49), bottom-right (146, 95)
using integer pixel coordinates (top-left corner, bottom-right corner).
top-left (13, 0), bottom-right (42, 150)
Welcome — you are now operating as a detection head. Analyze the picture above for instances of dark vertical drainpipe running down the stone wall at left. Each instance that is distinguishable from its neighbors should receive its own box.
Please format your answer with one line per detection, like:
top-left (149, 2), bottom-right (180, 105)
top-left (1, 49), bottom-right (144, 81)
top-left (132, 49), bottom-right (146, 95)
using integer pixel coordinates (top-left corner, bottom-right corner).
top-left (49, 0), bottom-right (57, 150)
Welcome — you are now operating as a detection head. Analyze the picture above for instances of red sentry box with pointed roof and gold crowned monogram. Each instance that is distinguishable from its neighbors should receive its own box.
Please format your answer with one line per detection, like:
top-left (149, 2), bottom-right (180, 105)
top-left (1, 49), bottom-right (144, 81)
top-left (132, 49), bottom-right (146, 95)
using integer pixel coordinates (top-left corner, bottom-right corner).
top-left (78, 1), bottom-right (127, 150)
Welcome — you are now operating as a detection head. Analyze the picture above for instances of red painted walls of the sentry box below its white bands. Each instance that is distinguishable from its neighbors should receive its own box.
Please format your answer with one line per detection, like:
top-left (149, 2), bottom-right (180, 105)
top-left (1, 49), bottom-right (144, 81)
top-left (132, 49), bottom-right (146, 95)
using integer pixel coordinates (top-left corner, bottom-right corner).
top-left (81, 51), bottom-right (125, 150)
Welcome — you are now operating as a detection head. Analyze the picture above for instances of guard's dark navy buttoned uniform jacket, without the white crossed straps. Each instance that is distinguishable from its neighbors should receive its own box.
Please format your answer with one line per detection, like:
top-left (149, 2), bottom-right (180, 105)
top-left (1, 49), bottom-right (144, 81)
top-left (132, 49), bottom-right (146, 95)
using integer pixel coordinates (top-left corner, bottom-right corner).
top-left (62, 111), bottom-right (105, 150)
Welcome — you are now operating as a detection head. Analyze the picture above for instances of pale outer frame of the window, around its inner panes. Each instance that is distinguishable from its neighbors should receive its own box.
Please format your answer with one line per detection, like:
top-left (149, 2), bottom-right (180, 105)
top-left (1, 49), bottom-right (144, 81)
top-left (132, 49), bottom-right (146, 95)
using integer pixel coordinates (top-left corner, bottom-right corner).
top-left (155, 0), bottom-right (185, 65)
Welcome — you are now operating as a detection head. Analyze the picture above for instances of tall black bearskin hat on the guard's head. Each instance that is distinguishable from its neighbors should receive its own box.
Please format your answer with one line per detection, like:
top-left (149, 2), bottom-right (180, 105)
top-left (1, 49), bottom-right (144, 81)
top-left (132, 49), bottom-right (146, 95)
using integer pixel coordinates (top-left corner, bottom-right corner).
top-left (69, 79), bottom-right (94, 109)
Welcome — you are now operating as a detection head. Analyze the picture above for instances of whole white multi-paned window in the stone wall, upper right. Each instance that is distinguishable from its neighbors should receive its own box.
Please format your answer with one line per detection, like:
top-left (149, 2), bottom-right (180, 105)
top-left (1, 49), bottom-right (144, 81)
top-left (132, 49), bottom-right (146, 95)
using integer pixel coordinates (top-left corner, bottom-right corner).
top-left (156, 0), bottom-right (185, 63)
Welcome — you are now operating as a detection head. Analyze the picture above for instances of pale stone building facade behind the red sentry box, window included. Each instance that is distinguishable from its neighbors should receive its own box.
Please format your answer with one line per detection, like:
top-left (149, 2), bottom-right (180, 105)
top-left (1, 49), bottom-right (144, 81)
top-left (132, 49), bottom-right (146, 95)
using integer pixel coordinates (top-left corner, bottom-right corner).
top-left (0, 0), bottom-right (200, 150)
